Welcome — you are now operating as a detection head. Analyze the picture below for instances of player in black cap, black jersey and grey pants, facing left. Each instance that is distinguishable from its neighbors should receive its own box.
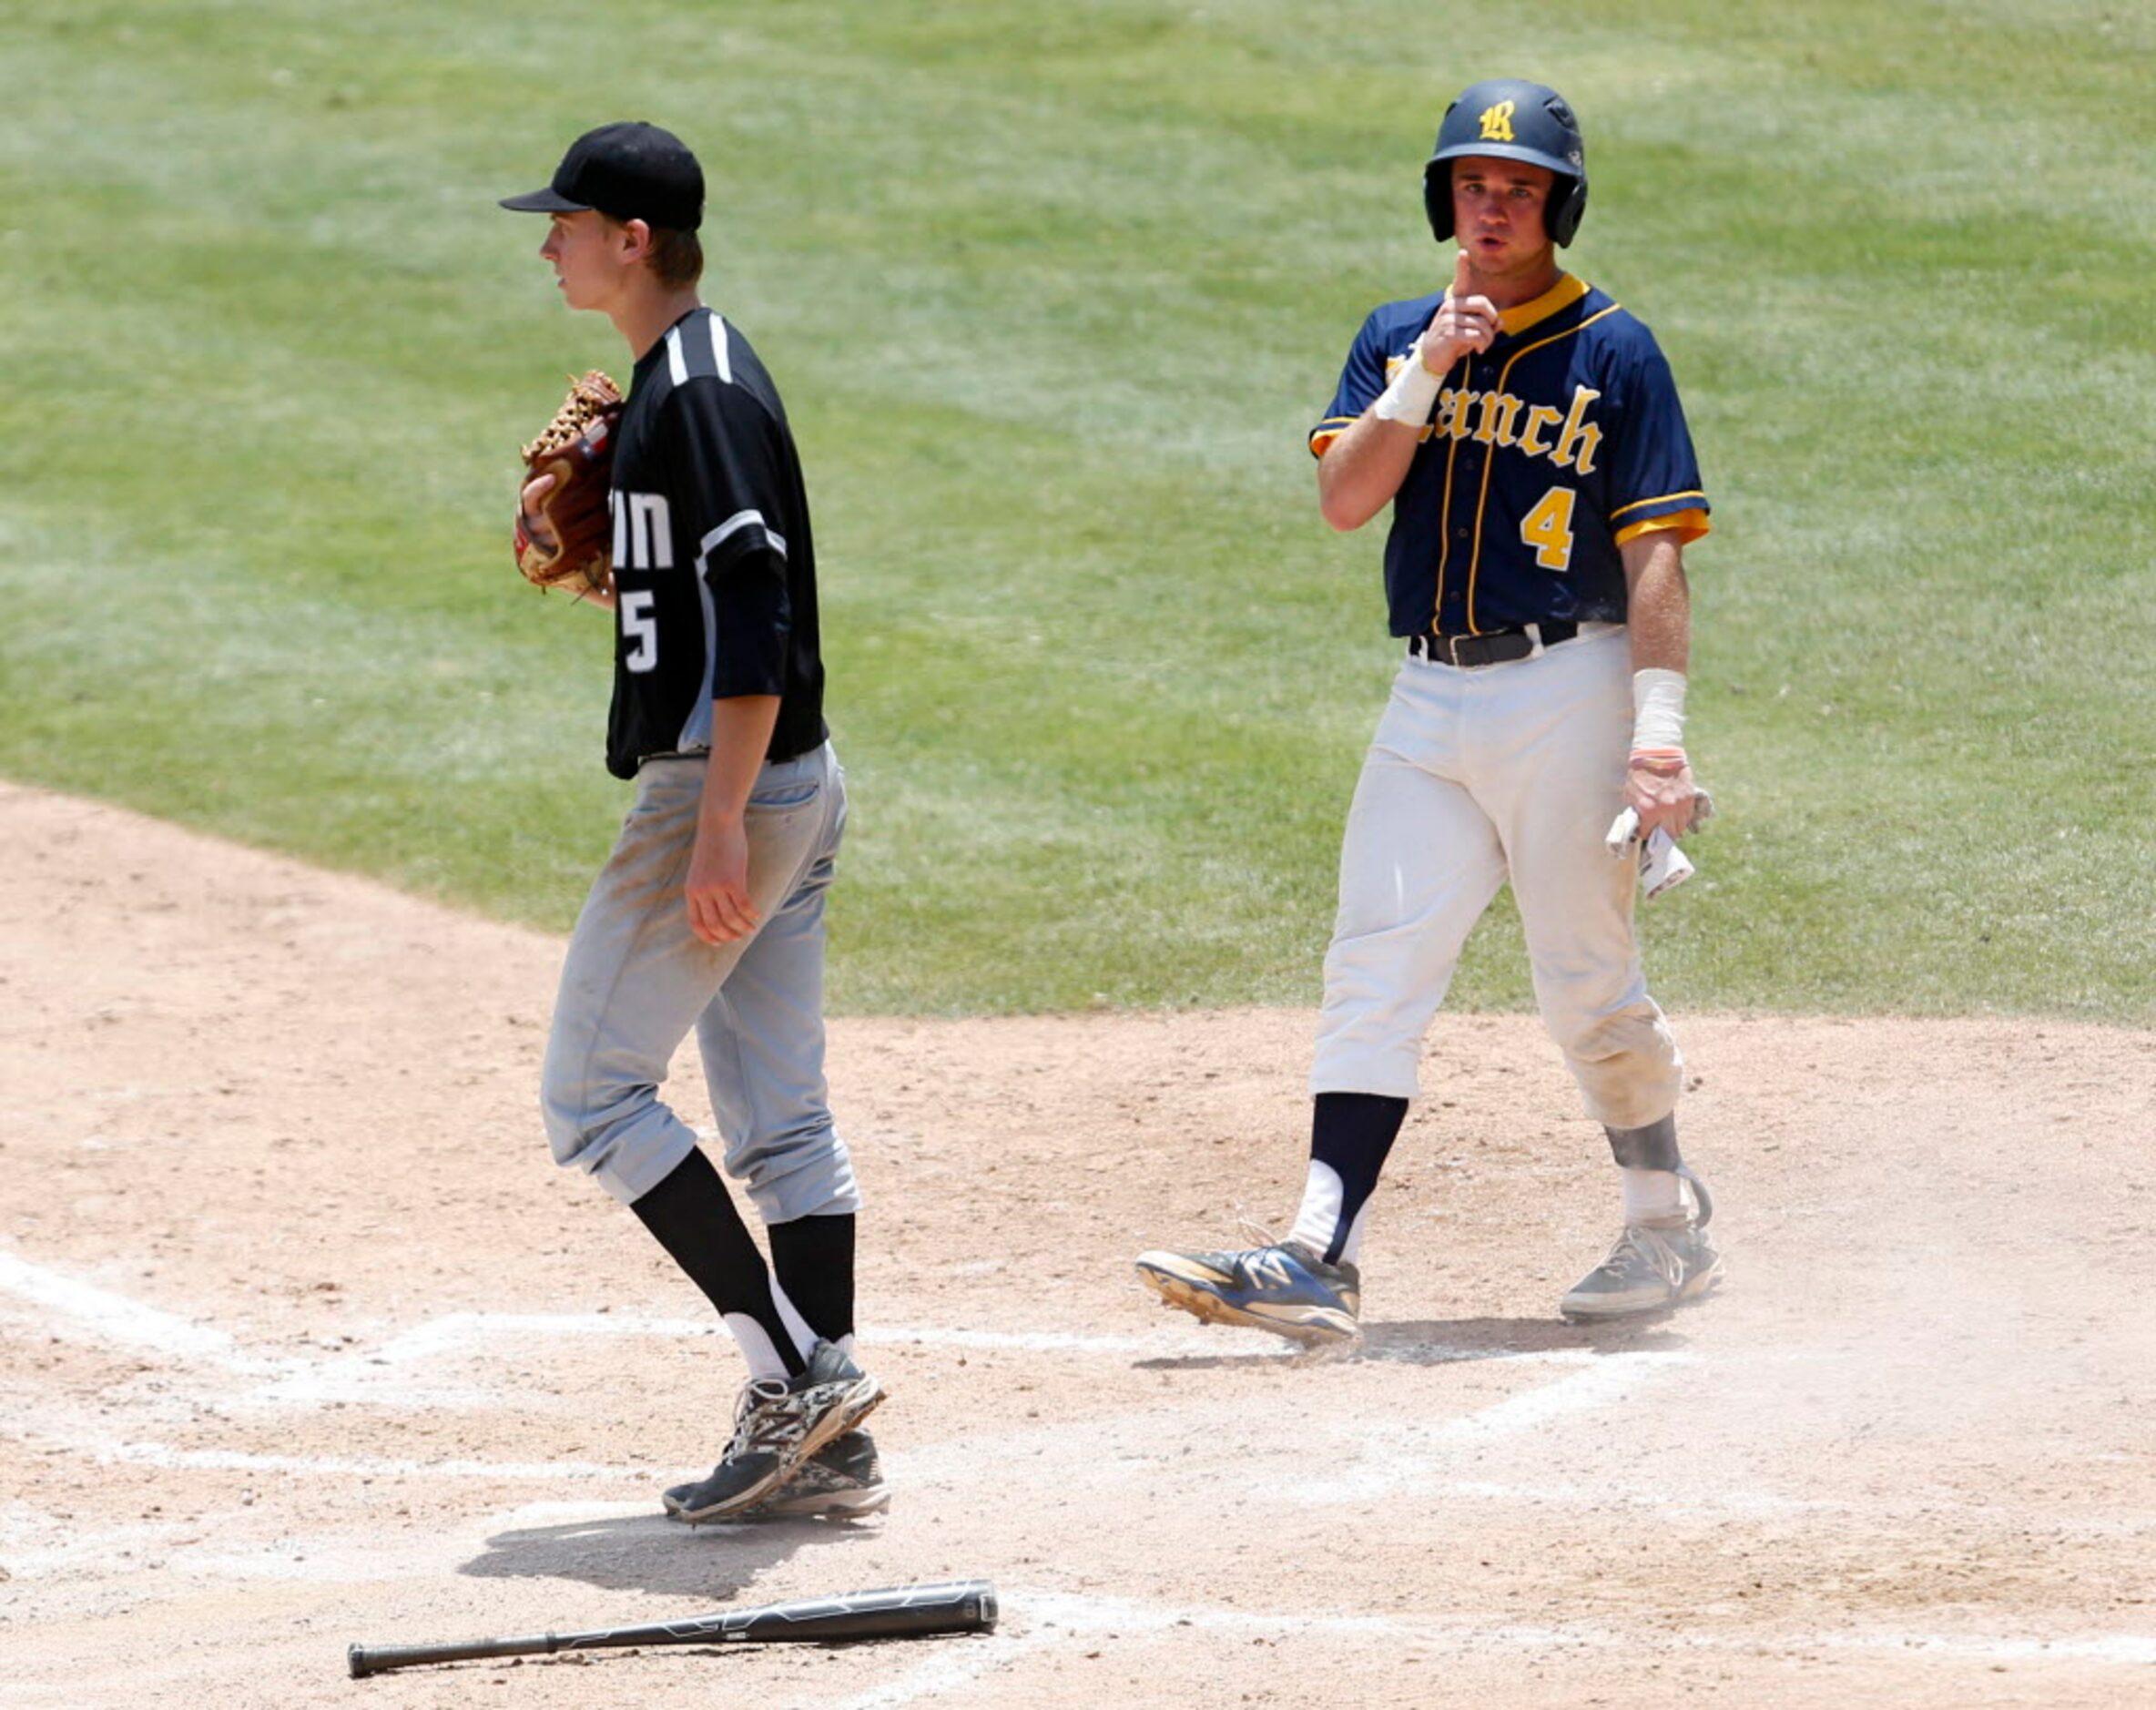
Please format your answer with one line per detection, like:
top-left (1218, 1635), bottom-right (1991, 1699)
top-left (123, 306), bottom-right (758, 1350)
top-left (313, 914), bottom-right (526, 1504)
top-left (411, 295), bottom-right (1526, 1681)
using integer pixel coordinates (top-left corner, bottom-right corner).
top-left (503, 123), bottom-right (884, 1521)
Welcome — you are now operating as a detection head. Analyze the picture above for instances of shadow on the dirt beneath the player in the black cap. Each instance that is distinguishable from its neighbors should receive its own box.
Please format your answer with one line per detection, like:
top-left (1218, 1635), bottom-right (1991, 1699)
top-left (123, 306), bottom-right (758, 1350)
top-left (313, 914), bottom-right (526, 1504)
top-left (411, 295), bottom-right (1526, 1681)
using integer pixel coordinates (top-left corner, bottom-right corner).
top-left (457, 1513), bottom-right (875, 1598)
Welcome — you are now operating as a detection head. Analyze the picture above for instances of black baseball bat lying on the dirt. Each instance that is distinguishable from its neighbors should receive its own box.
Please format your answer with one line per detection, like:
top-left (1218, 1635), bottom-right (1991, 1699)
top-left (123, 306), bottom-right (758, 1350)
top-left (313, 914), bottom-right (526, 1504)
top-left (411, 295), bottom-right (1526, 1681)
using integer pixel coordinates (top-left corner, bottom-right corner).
top-left (347, 1579), bottom-right (996, 1680)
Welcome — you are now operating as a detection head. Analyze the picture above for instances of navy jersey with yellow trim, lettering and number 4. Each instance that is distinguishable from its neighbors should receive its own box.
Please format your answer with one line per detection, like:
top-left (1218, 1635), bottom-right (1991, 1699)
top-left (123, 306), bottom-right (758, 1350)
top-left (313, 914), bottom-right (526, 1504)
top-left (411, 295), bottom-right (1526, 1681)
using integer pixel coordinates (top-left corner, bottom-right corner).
top-left (1311, 276), bottom-right (1707, 636)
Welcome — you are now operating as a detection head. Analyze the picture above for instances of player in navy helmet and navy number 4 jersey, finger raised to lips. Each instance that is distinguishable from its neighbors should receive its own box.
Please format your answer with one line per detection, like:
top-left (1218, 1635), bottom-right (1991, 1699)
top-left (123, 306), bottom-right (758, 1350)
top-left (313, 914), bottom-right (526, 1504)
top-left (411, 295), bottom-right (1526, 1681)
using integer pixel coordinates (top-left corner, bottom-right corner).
top-left (1138, 80), bottom-right (1723, 1343)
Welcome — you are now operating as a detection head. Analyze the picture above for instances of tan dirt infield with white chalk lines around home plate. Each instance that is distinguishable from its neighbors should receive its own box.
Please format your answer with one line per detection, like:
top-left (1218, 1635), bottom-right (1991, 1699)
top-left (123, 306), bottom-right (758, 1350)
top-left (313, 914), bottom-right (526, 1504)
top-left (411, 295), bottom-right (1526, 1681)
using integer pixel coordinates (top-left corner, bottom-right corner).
top-left (0, 785), bottom-right (2156, 1710)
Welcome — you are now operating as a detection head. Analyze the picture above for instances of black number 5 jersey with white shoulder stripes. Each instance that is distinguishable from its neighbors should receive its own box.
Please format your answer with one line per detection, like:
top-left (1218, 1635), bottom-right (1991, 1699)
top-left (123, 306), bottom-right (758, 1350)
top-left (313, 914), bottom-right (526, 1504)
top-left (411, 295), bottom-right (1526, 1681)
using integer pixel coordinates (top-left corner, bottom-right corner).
top-left (605, 309), bottom-right (826, 779)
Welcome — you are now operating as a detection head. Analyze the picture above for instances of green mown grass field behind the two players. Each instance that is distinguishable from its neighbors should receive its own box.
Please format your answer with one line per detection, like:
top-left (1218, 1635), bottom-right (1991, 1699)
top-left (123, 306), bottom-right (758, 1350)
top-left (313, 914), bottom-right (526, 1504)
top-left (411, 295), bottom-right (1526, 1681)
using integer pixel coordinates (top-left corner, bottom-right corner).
top-left (0, 0), bottom-right (2156, 1024)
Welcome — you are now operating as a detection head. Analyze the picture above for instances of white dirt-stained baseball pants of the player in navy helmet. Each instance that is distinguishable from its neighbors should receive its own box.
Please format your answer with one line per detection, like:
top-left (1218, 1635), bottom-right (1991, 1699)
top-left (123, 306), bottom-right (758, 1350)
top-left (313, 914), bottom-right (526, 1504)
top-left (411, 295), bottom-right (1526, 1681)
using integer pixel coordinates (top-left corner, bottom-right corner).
top-left (1311, 626), bottom-right (1683, 1128)
